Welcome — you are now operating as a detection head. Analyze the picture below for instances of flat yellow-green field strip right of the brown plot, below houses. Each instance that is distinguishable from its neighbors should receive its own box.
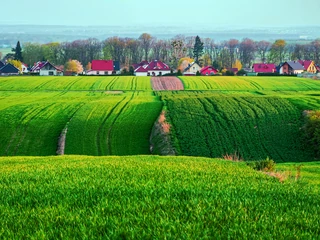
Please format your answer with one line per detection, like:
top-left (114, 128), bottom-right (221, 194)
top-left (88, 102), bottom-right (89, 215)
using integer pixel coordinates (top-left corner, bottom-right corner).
top-left (180, 76), bottom-right (320, 91)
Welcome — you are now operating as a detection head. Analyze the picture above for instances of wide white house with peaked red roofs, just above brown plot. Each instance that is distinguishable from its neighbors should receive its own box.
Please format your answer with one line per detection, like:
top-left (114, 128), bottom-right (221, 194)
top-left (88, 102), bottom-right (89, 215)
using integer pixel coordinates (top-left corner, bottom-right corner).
top-left (132, 60), bottom-right (171, 76)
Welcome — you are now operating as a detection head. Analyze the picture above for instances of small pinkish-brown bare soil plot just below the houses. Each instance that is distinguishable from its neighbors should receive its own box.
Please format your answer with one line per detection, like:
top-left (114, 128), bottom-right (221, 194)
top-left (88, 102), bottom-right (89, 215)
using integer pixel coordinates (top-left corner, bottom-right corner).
top-left (151, 77), bottom-right (184, 91)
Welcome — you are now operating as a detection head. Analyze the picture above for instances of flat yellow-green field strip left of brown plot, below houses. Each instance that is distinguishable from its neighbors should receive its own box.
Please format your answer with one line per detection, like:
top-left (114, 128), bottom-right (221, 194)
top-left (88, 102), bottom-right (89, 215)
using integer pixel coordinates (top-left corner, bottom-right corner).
top-left (0, 76), bottom-right (152, 91)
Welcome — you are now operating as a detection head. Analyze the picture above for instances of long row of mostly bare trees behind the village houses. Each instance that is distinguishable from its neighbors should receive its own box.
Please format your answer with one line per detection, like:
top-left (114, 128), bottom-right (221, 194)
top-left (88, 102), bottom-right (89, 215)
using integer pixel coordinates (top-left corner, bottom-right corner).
top-left (0, 33), bottom-right (320, 69)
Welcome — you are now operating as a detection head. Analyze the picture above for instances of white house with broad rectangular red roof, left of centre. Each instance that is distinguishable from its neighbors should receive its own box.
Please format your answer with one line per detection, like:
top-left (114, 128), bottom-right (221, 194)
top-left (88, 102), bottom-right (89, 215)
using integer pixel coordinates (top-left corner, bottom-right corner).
top-left (87, 60), bottom-right (120, 76)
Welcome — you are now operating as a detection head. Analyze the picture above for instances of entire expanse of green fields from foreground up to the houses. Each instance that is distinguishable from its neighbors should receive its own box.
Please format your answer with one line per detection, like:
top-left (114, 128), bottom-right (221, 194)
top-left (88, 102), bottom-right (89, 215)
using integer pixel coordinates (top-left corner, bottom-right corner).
top-left (0, 76), bottom-right (320, 239)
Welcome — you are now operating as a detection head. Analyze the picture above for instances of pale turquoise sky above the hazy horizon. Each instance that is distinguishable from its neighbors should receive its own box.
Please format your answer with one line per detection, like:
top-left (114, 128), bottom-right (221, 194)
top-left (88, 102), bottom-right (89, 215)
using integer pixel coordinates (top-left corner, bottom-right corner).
top-left (0, 0), bottom-right (320, 28)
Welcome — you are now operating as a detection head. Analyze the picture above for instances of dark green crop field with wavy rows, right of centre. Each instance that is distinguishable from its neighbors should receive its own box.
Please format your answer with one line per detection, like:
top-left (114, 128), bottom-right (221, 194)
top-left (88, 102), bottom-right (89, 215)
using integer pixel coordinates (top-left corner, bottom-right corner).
top-left (158, 92), bottom-right (313, 162)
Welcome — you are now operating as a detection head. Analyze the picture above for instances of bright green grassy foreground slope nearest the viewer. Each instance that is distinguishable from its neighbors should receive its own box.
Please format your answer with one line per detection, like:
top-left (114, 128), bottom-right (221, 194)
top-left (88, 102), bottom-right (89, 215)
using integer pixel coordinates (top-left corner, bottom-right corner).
top-left (0, 156), bottom-right (320, 239)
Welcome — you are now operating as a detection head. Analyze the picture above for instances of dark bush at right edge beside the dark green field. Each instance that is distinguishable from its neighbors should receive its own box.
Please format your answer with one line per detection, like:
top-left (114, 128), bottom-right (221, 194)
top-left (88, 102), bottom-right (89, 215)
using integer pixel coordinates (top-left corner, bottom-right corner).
top-left (303, 111), bottom-right (320, 157)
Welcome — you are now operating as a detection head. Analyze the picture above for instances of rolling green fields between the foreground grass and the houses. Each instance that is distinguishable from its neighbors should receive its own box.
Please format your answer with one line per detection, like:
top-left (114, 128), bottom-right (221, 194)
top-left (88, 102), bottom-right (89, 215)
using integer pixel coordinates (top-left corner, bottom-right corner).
top-left (0, 76), bottom-right (320, 162)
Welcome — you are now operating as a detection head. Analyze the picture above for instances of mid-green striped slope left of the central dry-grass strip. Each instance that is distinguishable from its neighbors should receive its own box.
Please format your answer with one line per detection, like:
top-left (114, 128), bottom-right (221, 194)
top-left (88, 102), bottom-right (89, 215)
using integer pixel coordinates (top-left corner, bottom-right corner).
top-left (0, 91), bottom-right (162, 156)
